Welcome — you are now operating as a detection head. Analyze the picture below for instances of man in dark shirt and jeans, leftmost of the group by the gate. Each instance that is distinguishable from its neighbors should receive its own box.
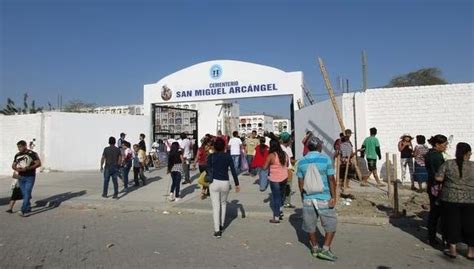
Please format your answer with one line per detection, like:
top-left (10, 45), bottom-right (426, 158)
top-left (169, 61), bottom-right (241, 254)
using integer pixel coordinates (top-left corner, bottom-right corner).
top-left (100, 136), bottom-right (122, 199)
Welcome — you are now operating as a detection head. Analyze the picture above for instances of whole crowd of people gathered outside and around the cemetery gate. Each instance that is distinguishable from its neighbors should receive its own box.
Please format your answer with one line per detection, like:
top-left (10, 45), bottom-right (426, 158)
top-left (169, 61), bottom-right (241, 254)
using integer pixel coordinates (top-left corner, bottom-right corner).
top-left (7, 128), bottom-right (474, 261)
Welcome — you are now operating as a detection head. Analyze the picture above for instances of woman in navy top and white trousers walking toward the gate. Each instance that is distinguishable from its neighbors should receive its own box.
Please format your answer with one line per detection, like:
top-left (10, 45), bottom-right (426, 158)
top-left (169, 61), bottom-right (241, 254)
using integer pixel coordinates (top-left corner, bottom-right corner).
top-left (206, 137), bottom-right (240, 238)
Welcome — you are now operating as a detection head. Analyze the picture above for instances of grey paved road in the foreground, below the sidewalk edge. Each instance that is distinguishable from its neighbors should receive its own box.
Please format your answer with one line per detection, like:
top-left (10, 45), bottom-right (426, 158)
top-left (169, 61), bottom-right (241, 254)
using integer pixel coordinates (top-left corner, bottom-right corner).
top-left (0, 206), bottom-right (472, 269)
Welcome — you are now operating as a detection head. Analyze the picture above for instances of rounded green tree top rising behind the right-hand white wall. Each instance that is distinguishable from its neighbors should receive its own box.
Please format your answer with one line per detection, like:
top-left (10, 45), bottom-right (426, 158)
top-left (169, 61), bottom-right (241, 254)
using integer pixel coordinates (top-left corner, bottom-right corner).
top-left (386, 67), bottom-right (448, 87)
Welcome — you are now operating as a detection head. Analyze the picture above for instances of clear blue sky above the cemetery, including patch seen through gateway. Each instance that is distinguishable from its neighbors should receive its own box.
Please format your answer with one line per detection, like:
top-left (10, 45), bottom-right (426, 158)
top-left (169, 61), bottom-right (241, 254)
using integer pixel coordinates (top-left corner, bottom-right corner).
top-left (0, 0), bottom-right (474, 115)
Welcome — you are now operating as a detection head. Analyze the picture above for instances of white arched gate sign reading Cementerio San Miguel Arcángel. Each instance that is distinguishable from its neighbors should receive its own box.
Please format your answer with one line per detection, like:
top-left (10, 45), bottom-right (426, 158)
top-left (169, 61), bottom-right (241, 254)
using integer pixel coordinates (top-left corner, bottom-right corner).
top-left (144, 60), bottom-right (303, 105)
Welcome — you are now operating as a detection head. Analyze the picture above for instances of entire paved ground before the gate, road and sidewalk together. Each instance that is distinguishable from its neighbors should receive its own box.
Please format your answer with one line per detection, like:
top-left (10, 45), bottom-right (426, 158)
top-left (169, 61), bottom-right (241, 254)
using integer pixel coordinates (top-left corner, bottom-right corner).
top-left (0, 170), bottom-right (472, 269)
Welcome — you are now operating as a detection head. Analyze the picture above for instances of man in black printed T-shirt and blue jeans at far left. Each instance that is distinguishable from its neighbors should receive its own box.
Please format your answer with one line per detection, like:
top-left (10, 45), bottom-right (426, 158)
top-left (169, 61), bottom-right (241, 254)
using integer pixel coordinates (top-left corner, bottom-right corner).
top-left (12, 140), bottom-right (41, 216)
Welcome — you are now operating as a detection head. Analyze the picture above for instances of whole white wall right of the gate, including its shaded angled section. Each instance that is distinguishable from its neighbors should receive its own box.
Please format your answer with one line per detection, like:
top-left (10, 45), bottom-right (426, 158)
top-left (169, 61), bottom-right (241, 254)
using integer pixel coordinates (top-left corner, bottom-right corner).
top-left (295, 83), bottom-right (474, 177)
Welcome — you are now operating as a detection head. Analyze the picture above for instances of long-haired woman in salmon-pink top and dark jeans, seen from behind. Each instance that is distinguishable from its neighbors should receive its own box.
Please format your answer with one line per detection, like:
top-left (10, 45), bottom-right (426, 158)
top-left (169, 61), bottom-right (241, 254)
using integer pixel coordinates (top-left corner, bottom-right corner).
top-left (263, 138), bottom-right (288, 223)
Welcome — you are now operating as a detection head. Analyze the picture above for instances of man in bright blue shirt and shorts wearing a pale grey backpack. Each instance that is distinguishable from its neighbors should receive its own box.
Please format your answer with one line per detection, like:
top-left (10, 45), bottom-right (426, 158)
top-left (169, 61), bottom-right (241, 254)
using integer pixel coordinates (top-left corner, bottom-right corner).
top-left (296, 136), bottom-right (337, 261)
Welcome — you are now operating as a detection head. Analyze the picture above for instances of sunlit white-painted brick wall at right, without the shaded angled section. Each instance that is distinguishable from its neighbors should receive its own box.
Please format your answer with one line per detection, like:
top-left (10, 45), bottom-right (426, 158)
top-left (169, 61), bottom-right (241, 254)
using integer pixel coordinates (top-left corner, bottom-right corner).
top-left (343, 83), bottom-right (474, 178)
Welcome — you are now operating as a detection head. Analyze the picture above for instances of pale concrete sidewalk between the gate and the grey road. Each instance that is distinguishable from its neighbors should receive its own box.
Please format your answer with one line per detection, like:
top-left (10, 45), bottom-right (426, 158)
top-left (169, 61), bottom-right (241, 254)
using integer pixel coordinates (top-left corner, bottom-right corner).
top-left (0, 168), bottom-right (383, 221)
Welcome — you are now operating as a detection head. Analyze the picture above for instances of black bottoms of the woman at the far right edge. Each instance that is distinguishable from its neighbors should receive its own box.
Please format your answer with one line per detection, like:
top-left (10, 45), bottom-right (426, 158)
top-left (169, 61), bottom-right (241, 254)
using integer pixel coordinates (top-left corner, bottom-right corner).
top-left (441, 201), bottom-right (474, 247)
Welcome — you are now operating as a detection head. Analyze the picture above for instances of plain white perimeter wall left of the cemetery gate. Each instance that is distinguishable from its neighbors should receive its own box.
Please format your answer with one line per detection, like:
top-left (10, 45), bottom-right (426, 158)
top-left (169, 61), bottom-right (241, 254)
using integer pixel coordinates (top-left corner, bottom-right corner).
top-left (0, 112), bottom-right (150, 175)
